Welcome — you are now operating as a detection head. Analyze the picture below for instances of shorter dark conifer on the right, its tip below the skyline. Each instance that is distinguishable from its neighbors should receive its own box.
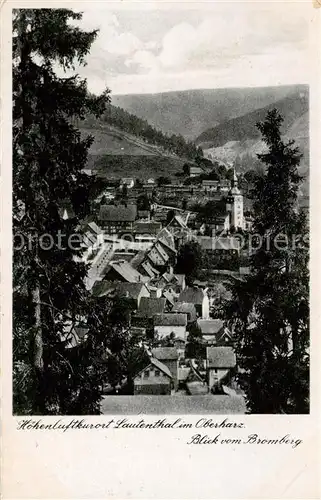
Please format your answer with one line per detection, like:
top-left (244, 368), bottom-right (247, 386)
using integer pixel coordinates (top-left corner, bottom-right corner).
top-left (227, 109), bottom-right (309, 413)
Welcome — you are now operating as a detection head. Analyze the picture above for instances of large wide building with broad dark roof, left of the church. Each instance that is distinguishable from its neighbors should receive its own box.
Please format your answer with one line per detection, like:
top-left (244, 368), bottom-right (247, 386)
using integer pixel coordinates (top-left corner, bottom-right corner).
top-left (98, 205), bottom-right (137, 234)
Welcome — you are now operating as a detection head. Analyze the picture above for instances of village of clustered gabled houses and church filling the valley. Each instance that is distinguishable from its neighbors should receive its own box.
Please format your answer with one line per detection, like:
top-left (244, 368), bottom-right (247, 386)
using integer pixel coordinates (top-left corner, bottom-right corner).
top-left (62, 158), bottom-right (252, 410)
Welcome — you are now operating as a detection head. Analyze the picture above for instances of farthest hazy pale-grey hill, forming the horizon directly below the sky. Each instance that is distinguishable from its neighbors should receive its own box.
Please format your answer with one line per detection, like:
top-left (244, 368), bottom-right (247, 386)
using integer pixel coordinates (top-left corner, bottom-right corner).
top-left (112, 85), bottom-right (306, 140)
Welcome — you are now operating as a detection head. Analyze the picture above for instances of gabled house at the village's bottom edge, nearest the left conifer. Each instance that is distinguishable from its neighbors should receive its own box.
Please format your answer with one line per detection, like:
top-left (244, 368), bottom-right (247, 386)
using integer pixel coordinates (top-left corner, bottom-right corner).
top-left (134, 357), bottom-right (173, 396)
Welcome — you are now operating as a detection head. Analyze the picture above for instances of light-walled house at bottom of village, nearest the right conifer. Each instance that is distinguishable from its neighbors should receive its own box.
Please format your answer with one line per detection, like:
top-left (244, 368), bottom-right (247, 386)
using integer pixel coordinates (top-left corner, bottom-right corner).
top-left (206, 346), bottom-right (236, 389)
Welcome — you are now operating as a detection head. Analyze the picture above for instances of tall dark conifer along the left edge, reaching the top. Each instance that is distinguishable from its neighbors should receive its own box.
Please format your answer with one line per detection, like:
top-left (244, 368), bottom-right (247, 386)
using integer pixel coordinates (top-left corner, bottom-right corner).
top-left (13, 9), bottom-right (109, 414)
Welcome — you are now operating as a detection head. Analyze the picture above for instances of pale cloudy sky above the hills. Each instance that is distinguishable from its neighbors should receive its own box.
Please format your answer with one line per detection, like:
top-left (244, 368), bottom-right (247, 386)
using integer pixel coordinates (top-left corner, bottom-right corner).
top-left (69, 0), bottom-right (310, 95)
